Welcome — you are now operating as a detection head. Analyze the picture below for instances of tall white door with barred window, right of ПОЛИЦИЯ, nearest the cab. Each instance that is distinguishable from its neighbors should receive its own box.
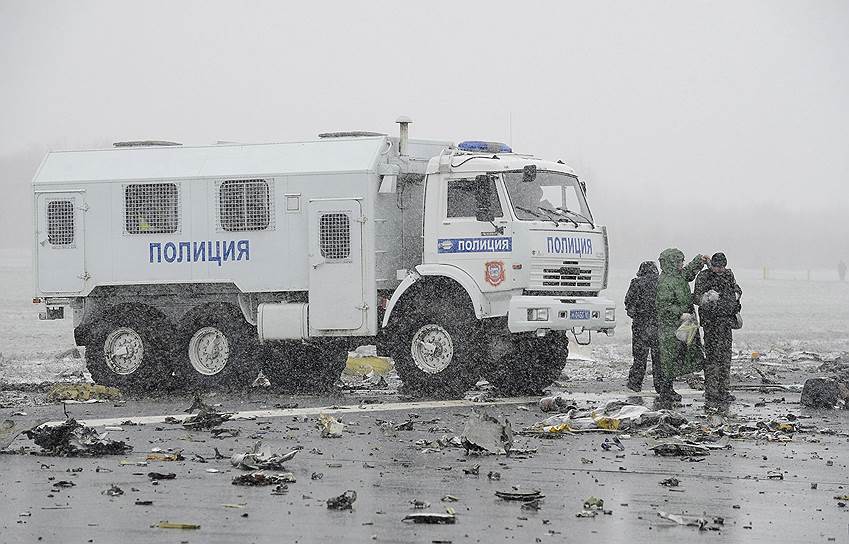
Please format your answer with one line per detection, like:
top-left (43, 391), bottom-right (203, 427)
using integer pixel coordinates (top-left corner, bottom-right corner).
top-left (309, 199), bottom-right (366, 330)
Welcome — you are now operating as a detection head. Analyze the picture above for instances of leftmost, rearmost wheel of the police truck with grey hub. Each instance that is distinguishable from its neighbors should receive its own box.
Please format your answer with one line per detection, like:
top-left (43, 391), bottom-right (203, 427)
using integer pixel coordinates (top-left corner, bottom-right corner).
top-left (86, 312), bottom-right (173, 393)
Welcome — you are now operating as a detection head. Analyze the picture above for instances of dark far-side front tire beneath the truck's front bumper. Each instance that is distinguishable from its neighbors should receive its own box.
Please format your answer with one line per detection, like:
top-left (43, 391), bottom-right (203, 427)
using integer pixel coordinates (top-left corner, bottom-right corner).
top-left (485, 334), bottom-right (569, 396)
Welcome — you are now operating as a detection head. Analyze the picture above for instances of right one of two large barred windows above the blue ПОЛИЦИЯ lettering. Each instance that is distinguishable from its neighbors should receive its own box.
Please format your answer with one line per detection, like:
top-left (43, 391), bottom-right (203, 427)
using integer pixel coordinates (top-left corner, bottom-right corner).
top-left (218, 179), bottom-right (271, 231)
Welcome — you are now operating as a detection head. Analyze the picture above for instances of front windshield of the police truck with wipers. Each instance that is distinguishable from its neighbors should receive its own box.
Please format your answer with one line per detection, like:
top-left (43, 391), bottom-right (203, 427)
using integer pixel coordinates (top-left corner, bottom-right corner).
top-left (503, 171), bottom-right (592, 223)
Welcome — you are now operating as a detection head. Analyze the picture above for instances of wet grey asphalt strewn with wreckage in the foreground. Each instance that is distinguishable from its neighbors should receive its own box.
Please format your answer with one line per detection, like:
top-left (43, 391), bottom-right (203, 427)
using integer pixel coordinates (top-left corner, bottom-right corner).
top-left (0, 391), bottom-right (849, 544)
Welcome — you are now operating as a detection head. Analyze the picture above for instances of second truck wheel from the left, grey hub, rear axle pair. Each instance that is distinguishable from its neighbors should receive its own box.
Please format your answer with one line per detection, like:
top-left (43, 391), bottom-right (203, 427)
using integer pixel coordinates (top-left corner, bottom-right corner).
top-left (178, 310), bottom-right (259, 389)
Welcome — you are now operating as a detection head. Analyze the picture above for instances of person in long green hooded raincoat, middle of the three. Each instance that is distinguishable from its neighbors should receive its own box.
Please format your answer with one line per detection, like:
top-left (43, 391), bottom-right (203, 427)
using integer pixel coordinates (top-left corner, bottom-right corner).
top-left (654, 248), bottom-right (708, 403)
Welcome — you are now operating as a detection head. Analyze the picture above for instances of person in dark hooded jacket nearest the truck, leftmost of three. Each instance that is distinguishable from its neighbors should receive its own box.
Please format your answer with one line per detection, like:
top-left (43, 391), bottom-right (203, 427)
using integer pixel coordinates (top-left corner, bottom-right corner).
top-left (625, 261), bottom-right (662, 393)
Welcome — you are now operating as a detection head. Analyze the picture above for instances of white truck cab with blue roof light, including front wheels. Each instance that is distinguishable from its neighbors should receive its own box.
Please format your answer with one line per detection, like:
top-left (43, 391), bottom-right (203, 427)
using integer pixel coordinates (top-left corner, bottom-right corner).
top-left (384, 141), bottom-right (616, 393)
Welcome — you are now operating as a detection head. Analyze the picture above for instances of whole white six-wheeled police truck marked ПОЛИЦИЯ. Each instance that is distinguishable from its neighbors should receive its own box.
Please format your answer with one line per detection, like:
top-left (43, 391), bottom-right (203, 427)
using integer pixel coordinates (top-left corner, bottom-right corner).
top-left (33, 118), bottom-right (616, 396)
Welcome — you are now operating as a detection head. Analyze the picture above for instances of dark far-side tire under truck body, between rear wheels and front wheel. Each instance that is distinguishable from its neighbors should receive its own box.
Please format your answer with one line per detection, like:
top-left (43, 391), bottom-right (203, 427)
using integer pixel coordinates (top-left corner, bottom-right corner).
top-left (263, 341), bottom-right (348, 393)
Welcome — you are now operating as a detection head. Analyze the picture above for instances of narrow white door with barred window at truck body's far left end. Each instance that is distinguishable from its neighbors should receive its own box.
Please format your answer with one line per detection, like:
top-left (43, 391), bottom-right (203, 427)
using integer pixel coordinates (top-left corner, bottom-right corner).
top-left (35, 191), bottom-right (87, 293)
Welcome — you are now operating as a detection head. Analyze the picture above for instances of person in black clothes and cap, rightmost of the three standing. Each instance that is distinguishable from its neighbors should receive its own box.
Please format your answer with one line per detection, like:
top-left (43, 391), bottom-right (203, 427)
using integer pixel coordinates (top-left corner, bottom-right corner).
top-left (693, 253), bottom-right (743, 404)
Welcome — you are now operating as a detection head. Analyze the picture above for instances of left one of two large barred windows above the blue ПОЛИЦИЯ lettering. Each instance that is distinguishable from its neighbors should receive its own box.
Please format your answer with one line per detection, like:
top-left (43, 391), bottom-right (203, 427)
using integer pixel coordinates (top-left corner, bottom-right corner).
top-left (124, 183), bottom-right (180, 234)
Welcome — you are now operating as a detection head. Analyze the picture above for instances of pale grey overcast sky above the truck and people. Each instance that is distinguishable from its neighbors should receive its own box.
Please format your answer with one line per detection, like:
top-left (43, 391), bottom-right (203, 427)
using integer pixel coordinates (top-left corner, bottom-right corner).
top-left (0, 0), bottom-right (849, 267)
